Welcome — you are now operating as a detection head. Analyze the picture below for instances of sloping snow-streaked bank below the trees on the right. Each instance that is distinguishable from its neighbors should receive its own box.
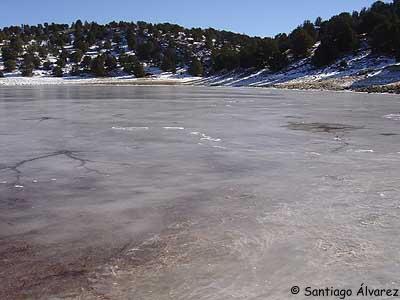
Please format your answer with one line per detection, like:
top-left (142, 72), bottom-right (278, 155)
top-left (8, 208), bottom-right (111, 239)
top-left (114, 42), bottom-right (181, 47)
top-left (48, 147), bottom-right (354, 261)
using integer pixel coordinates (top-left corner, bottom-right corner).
top-left (192, 49), bottom-right (400, 91)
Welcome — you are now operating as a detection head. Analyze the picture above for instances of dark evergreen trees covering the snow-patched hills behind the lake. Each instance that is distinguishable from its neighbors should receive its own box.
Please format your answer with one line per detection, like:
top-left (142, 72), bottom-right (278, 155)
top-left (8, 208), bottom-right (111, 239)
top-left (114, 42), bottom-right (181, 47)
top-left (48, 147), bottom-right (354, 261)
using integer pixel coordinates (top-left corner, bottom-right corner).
top-left (0, 0), bottom-right (400, 77)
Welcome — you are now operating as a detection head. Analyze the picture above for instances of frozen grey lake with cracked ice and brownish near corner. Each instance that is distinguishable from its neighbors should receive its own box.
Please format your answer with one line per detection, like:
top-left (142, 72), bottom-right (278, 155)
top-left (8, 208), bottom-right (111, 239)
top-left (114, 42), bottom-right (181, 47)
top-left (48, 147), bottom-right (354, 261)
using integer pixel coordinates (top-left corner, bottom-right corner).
top-left (0, 86), bottom-right (400, 300)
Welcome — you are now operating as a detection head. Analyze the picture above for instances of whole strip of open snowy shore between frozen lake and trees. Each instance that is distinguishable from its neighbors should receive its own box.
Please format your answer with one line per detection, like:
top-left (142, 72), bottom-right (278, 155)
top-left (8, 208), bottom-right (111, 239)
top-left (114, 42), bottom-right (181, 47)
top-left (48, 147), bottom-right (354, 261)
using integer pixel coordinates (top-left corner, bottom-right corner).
top-left (0, 49), bottom-right (400, 92)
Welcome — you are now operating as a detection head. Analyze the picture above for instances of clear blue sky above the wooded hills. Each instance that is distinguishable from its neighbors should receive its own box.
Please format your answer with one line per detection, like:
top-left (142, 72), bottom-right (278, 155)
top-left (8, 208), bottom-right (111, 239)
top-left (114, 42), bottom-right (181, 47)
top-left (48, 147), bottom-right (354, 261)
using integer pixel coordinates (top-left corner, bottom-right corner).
top-left (0, 0), bottom-right (384, 36)
